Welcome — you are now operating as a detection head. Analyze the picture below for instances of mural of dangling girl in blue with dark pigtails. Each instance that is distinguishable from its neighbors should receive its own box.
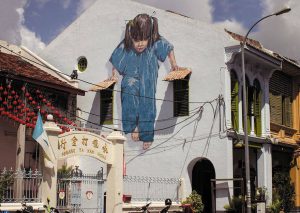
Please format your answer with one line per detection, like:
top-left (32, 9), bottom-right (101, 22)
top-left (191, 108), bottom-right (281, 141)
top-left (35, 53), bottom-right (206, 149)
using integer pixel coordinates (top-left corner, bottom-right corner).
top-left (110, 14), bottom-right (178, 149)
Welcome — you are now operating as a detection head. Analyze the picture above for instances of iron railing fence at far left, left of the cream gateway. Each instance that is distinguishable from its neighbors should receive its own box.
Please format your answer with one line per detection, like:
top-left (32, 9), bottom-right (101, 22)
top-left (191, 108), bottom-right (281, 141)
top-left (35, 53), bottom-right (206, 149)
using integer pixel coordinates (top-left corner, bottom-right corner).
top-left (0, 168), bottom-right (42, 203)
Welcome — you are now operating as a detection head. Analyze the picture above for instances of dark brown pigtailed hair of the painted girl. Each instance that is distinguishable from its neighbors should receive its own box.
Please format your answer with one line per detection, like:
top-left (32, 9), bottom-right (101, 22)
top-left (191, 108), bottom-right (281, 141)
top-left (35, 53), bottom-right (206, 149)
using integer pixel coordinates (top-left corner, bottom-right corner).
top-left (124, 14), bottom-right (160, 50)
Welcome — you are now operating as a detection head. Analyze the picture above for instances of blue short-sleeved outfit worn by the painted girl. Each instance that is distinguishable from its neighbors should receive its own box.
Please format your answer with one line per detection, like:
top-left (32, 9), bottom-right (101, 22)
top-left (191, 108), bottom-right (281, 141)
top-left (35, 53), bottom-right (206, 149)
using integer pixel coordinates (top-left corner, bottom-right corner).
top-left (110, 38), bottom-right (173, 142)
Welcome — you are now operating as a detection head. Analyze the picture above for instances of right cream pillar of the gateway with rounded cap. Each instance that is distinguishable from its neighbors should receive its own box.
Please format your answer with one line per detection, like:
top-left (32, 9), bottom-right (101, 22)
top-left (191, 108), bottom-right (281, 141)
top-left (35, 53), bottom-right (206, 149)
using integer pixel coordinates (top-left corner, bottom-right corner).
top-left (106, 131), bottom-right (126, 213)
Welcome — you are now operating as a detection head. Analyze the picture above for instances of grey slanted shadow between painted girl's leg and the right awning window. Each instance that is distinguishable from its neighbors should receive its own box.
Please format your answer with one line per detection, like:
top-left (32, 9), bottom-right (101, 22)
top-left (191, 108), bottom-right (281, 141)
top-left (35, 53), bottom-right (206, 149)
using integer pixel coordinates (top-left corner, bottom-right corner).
top-left (154, 83), bottom-right (177, 135)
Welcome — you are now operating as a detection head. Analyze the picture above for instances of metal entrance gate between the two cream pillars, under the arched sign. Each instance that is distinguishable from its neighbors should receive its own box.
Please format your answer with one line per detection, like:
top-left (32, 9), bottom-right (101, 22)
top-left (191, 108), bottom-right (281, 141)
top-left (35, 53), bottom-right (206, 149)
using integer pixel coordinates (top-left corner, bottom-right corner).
top-left (57, 166), bottom-right (105, 213)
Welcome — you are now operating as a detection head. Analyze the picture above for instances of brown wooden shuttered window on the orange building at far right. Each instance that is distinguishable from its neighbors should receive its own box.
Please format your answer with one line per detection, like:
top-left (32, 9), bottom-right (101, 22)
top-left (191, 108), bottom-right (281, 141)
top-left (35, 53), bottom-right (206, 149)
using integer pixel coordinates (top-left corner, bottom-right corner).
top-left (269, 71), bottom-right (293, 127)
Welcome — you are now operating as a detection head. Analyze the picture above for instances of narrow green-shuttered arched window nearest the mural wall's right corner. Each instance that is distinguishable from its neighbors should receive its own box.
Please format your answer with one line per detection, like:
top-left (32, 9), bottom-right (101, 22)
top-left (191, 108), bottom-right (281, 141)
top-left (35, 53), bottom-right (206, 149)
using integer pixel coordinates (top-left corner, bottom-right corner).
top-left (230, 70), bottom-right (239, 130)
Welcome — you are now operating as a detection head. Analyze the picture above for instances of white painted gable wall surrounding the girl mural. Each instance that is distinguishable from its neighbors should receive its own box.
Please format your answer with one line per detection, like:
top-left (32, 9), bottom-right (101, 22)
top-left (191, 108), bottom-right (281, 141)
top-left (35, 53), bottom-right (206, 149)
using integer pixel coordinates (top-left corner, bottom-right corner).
top-left (41, 0), bottom-right (238, 209)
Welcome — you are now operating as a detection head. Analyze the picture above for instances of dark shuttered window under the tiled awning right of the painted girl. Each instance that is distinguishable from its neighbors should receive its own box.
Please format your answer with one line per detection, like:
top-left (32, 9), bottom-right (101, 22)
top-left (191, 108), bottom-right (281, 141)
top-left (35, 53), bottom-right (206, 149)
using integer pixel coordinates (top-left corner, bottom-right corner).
top-left (173, 76), bottom-right (189, 117)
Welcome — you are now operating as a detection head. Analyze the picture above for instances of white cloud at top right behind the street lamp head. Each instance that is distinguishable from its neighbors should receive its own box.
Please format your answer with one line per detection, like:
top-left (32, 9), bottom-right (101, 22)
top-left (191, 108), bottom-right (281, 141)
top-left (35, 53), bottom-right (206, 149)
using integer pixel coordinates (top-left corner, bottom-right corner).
top-left (254, 0), bottom-right (300, 60)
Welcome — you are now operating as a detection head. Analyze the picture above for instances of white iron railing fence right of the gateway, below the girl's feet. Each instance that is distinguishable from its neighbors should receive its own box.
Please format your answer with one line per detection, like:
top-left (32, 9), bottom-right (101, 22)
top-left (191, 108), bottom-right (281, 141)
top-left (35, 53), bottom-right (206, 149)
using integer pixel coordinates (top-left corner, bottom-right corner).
top-left (124, 176), bottom-right (180, 202)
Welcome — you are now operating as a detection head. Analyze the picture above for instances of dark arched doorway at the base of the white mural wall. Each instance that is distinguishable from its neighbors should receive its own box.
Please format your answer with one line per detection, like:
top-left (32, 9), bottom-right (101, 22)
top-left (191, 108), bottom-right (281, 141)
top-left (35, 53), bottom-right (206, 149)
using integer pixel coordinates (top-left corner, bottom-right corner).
top-left (192, 158), bottom-right (216, 212)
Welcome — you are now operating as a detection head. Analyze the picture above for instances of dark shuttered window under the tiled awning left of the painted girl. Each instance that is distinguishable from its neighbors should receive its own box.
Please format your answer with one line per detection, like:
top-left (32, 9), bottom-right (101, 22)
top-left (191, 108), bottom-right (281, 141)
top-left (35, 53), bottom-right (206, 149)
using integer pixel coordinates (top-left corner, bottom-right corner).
top-left (100, 85), bottom-right (114, 125)
